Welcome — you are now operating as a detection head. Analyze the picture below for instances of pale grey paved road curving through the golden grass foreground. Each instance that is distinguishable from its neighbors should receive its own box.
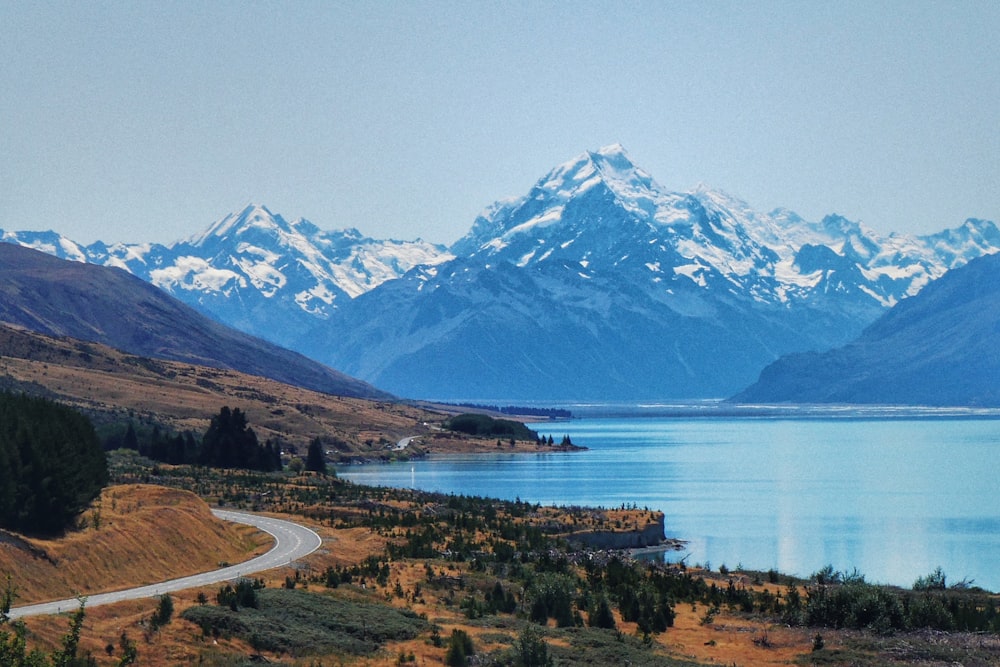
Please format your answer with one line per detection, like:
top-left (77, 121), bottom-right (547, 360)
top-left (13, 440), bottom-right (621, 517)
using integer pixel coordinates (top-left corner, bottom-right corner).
top-left (10, 510), bottom-right (323, 618)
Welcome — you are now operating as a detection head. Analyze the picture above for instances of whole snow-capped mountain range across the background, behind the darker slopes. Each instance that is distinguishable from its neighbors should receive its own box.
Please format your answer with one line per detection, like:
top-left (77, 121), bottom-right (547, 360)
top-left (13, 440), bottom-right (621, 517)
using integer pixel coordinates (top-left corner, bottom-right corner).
top-left (2, 145), bottom-right (1000, 400)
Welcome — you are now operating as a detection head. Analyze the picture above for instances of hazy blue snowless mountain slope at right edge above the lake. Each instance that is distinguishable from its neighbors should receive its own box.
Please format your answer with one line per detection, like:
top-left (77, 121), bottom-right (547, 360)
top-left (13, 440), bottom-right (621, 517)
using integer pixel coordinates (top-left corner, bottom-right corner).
top-left (733, 250), bottom-right (1000, 407)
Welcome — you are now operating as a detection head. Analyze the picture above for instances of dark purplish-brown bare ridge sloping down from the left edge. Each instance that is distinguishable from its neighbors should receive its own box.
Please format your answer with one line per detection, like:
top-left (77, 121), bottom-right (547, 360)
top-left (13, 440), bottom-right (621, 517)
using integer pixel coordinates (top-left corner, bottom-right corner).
top-left (0, 243), bottom-right (389, 398)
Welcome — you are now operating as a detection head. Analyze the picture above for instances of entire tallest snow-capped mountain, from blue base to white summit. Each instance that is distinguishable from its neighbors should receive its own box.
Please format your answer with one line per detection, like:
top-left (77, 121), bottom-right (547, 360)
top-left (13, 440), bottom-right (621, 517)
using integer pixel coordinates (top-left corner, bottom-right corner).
top-left (295, 145), bottom-right (1000, 400)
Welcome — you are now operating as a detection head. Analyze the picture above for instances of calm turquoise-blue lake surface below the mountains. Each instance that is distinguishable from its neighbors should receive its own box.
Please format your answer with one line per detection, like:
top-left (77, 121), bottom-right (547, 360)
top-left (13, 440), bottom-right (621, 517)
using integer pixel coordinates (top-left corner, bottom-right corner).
top-left (338, 412), bottom-right (1000, 591)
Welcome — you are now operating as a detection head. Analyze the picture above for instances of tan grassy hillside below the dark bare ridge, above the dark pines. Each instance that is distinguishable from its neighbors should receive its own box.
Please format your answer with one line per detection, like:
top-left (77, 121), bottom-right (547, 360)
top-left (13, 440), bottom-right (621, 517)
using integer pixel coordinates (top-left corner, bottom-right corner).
top-left (0, 325), bottom-right (441, 455)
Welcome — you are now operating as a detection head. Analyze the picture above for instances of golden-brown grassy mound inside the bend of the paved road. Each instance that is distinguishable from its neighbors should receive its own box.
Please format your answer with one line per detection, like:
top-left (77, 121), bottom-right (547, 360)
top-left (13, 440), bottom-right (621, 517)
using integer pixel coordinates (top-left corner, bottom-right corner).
top-left (0, 484), bottom-right (271, 605)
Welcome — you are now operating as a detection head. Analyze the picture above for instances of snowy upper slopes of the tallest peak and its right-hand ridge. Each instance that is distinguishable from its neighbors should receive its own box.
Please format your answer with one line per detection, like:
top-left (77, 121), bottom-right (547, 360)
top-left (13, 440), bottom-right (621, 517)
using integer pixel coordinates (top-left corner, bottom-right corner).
top-left (451, 144), bottom-right (1000, 316)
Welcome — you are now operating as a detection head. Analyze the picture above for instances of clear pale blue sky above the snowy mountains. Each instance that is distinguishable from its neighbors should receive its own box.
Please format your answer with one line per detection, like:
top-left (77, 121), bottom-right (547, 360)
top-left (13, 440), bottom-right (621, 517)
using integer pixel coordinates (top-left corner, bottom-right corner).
top-left (0, 0), bottom-right (1000, 244)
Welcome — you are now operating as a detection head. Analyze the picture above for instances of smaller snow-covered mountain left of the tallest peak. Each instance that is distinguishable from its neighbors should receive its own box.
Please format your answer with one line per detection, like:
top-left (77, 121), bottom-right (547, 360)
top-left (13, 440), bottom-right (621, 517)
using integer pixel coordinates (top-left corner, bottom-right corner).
top-left (2, 205), bottom-right (451, 345)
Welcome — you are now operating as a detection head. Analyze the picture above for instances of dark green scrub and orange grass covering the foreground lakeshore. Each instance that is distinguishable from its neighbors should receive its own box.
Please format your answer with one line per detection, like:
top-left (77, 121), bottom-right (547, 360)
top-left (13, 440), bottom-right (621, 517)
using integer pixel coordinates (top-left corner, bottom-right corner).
top-left (0, 400), bottom-right (1000, 667)
